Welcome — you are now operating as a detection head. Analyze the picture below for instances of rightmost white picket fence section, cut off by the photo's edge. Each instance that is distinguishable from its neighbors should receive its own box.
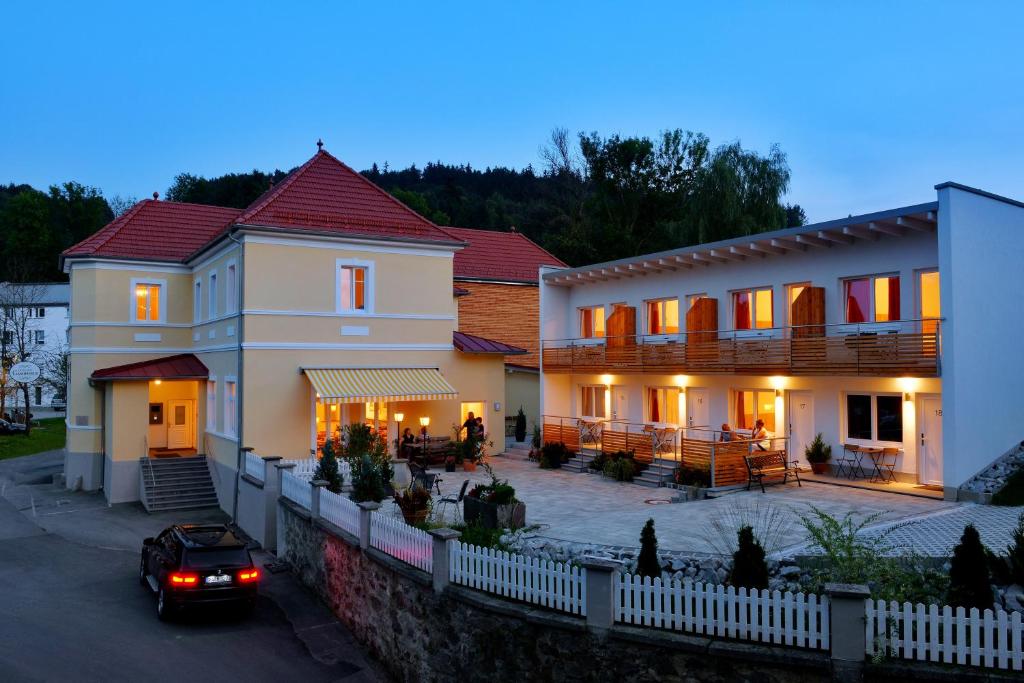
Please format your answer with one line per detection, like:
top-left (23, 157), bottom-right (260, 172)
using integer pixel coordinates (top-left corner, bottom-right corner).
top-left (864, 600), bottom-right (1024, 671)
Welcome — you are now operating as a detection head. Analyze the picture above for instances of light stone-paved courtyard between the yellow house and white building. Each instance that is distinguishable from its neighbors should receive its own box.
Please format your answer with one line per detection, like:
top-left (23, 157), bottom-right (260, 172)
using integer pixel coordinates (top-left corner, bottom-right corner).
top-left (432, 458), bottom-right (966, 553)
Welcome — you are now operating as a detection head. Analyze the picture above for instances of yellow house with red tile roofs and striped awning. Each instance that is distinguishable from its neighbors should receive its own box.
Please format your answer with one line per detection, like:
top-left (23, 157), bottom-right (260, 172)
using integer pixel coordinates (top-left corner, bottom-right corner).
top-left (61, 150), bottom-right (524, 510)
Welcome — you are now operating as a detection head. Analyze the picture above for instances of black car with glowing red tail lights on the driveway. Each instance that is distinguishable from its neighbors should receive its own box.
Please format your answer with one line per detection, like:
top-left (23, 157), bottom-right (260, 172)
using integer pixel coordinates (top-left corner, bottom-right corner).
top-left (138, 524), bottom-right (260, 620)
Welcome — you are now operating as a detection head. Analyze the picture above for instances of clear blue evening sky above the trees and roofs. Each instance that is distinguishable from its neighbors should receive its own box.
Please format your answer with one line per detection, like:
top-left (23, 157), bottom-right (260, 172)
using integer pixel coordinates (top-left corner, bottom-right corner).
top-left (0, 1), bottom-right (1024, 220)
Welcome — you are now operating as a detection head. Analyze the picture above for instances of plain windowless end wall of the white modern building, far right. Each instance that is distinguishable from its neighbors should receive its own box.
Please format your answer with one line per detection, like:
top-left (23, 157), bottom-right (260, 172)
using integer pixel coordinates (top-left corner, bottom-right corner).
top-left (938, 185), bottom-right (1024, 486)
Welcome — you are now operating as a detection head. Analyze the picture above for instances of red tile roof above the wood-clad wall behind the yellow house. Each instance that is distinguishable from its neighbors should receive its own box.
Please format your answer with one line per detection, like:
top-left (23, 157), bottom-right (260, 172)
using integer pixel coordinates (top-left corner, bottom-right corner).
top-left (444, 227), bottom-right (567, 283)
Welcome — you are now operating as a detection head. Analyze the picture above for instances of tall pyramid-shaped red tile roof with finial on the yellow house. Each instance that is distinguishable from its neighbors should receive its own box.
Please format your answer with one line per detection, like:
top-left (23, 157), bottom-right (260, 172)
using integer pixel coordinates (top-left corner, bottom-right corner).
top-left (237, 151), bottom-right (458, 242)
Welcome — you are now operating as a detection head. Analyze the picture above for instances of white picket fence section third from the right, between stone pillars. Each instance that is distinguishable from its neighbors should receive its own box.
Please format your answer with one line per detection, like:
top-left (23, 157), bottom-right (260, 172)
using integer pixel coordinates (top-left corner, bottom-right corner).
top-left (449, 541), bottom-right (587, 615)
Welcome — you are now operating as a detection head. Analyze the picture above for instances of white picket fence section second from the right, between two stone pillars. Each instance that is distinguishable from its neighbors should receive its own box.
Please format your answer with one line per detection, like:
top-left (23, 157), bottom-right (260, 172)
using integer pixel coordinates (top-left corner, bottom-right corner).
top-left (615, 574), bottom-right (828, 650)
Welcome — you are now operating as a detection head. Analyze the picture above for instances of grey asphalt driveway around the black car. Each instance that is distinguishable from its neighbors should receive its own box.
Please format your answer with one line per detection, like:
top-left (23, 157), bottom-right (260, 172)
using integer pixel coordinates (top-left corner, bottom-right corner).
top-left (0, 453), bottom-right (386, 682)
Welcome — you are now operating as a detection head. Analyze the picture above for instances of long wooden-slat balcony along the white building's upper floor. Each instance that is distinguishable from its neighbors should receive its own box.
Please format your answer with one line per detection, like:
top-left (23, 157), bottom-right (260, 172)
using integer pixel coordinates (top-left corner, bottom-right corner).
top-left (541, 319), bottom-right (941, 377)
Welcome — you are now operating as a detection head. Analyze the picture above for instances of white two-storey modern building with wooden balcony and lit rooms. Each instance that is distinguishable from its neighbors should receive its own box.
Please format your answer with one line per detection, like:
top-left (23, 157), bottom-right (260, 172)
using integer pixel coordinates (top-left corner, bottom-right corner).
top-left (541, 182), bottom-right (1024, 498)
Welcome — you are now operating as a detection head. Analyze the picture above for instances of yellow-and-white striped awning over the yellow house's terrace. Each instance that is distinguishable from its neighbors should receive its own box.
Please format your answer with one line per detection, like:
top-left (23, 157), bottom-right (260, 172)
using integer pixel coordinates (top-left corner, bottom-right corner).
top-left (302, 368), bottom-right (459, 403)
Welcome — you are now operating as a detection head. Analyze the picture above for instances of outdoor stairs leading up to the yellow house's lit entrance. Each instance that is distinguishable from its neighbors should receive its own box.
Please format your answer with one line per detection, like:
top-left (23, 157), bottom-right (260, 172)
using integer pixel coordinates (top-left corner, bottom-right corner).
top-left (139, 456), bottom-right (218, 512)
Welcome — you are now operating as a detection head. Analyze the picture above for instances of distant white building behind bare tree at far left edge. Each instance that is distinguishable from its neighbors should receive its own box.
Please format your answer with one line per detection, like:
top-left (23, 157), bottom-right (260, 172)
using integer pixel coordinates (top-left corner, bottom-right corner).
top-left (0, 283), bottom-right (71, 411)
